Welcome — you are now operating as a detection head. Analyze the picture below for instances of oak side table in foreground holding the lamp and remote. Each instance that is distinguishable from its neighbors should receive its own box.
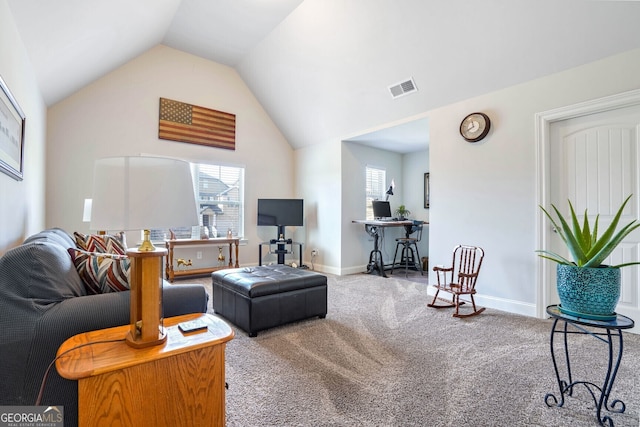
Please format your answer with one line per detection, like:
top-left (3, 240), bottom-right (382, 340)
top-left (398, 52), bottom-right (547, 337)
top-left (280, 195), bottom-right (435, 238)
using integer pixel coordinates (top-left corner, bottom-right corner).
top-left (56, 313), bottom-right (234, 427)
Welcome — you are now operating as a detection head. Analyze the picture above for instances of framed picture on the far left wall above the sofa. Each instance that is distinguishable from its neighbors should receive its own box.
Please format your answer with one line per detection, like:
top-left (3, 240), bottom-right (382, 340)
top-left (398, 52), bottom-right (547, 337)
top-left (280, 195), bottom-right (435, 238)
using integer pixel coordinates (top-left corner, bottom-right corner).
top-left (0, 77), bottom-right (25, 181)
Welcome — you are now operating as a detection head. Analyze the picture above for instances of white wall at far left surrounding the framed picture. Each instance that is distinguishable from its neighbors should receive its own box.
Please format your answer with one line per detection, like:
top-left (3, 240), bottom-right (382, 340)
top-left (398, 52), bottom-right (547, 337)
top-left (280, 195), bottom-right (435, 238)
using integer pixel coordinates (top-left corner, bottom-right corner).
top-left (0, 0), bottom-right (46, 254)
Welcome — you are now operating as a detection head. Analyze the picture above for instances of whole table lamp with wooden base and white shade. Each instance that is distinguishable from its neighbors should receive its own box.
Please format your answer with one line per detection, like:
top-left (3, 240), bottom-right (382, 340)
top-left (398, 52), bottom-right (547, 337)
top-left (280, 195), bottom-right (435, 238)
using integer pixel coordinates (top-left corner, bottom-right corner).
top-left (90, 156), bottom-right (198, 348)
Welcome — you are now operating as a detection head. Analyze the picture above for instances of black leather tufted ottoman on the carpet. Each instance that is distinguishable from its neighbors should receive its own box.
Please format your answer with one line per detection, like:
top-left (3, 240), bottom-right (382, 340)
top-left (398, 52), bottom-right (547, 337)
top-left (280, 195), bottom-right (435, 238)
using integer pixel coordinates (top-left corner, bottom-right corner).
top-left (211, 265), bottom-right (327, 337)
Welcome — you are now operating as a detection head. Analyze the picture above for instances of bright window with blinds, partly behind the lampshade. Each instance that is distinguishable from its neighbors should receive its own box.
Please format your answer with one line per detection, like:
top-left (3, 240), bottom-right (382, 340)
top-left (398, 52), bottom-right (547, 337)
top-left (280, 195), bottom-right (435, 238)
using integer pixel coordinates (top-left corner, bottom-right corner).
top-left (151, 163), bottom-right (244, 240)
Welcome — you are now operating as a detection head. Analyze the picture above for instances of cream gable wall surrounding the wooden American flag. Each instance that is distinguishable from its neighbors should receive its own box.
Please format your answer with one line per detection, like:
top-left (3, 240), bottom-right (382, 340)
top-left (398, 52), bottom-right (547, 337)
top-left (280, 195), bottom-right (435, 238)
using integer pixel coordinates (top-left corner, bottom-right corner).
top-left (46, 45), bottom-right (295, 267)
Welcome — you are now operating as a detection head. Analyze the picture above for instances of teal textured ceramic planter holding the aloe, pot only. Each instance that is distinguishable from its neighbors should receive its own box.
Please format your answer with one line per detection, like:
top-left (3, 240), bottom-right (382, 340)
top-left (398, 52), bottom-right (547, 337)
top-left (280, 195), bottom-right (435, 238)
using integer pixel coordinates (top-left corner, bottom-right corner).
top-left (556, 264), bottom-right (620, 320)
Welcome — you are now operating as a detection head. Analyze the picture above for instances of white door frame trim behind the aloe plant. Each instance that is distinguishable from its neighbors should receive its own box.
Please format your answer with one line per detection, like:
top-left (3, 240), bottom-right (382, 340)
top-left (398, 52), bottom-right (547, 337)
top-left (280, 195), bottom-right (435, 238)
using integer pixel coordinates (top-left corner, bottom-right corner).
top-left (535, 89), bottom-right (640, 318)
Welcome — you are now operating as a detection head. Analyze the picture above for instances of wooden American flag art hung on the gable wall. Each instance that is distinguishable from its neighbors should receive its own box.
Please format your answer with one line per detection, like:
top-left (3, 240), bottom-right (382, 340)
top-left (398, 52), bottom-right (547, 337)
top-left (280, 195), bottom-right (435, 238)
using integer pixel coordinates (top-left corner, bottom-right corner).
top-left (158, 98), bottom-right (236, 150)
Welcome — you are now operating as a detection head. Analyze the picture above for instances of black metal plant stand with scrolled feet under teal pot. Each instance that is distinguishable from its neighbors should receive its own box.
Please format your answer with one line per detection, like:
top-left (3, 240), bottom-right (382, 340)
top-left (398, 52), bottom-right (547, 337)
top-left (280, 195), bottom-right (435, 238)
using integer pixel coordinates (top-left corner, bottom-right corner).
top-left (544, 305), bottom-right (634, 427)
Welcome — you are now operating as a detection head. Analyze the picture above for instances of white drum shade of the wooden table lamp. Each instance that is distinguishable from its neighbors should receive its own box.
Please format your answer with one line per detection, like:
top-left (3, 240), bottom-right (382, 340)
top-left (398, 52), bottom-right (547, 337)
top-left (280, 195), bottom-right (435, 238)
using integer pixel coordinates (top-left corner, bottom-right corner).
top-left (90, 156), bottom-right (198, 231)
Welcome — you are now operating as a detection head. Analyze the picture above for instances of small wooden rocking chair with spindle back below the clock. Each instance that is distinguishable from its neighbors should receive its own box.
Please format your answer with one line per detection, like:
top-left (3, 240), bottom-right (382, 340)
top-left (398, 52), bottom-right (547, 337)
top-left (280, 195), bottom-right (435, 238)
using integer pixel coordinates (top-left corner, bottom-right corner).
top-left (427, 245), bottom-right (485, 317)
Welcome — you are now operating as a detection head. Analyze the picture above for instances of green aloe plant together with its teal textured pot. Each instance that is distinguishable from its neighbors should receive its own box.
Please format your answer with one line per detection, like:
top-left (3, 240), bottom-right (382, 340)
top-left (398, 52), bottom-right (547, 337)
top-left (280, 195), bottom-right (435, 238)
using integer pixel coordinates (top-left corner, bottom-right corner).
top-left (536, 195), bottom-right (640, 320)
